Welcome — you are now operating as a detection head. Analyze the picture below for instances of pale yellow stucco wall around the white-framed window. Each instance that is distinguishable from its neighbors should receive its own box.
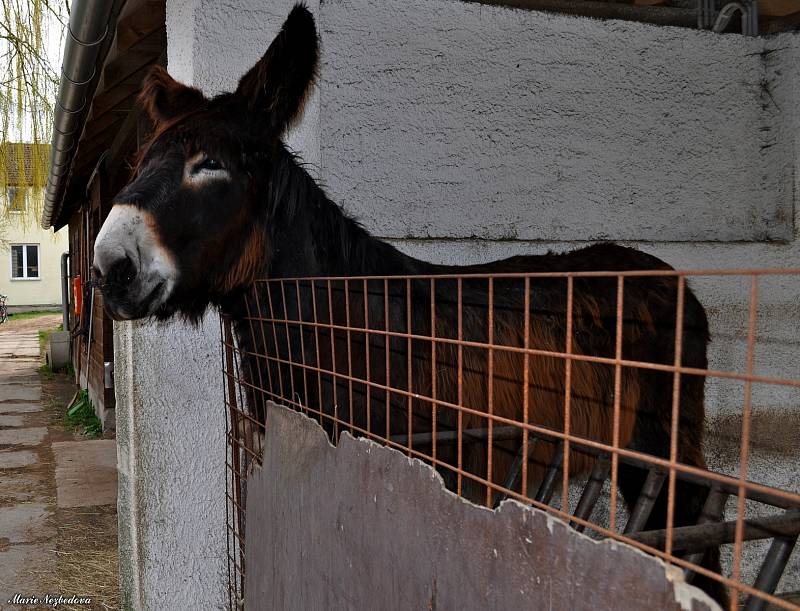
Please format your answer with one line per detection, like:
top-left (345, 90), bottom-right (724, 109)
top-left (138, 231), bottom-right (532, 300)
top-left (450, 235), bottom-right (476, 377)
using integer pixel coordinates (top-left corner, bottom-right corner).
top-left (0, 215), bottom-right (69, 306)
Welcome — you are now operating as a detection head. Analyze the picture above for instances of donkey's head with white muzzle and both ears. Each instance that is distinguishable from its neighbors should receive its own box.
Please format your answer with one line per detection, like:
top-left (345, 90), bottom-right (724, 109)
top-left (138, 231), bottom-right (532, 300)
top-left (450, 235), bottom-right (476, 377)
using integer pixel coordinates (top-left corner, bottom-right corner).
top-left (94, 5), bottom-right (319, 320)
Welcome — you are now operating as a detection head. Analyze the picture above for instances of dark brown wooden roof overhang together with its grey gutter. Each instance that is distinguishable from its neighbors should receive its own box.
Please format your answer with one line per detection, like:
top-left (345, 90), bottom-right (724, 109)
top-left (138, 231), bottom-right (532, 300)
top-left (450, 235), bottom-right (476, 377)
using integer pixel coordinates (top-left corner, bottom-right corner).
top-left (41, 0), bottom-right (166, 230)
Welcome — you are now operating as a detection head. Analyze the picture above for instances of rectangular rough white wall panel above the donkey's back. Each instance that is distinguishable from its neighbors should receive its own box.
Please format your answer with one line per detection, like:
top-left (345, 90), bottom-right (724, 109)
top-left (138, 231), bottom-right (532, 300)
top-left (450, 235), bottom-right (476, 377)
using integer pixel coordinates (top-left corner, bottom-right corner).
top-left (321, 0), bottom-right (793, 240)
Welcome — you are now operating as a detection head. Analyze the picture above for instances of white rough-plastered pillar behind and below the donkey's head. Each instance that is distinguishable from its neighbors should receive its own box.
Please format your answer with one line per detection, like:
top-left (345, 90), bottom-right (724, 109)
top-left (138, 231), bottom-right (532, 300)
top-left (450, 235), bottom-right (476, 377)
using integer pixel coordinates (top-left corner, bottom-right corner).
top-left (115, 0), bottom-right (319, 610)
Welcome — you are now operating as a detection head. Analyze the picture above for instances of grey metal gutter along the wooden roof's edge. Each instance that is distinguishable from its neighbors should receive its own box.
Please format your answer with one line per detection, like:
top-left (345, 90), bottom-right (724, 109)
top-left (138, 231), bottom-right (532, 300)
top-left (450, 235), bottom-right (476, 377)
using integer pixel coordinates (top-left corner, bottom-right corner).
top-left (41, 0), bottom-right (118, 229)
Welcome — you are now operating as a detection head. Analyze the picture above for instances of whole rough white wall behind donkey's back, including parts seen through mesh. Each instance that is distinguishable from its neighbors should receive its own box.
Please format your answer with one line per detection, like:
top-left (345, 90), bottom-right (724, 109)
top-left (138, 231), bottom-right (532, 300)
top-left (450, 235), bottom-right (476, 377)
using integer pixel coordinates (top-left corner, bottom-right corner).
top-left (320, 0), bottom-right (800, 590)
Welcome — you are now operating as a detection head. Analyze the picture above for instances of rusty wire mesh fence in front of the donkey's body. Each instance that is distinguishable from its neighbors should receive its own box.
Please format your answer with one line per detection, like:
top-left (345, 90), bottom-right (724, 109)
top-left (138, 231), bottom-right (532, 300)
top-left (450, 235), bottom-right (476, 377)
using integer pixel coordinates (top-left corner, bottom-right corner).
top-left (221, 269), bottom-right (800, 611)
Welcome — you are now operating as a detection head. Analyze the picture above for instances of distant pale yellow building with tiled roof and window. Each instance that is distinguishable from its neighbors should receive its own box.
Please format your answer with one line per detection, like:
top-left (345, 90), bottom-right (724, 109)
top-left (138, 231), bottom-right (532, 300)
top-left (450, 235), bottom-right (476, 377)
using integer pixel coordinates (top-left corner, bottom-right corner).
top-left (0, 145), bottom-right (69, 309)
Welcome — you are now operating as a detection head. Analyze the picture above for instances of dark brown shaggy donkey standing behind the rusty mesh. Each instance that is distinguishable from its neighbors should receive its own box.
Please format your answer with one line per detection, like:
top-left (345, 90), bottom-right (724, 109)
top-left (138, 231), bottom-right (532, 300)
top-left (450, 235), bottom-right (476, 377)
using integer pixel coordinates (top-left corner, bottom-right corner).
top-left (94, 5), bottom-right (726, 602)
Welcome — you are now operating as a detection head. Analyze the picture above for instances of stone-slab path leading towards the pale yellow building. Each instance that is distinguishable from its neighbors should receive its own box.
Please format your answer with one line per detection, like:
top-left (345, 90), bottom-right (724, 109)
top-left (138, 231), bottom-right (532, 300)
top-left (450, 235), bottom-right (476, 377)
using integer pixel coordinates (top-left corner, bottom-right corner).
top-left (0, 326), bottom-right (116, 610)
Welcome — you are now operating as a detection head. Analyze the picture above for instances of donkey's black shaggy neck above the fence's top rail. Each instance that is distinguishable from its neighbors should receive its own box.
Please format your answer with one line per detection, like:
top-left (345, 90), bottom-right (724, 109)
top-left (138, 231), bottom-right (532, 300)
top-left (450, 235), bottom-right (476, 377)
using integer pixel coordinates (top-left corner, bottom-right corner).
top-left (267, 147), bottom-right (436, 278)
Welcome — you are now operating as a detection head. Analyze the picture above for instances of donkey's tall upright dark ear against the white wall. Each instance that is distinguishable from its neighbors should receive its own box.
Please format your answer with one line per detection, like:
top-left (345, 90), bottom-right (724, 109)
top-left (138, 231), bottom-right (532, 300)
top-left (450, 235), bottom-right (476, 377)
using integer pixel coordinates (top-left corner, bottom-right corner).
top-left (236, 4), bottom-right (319, 134)
